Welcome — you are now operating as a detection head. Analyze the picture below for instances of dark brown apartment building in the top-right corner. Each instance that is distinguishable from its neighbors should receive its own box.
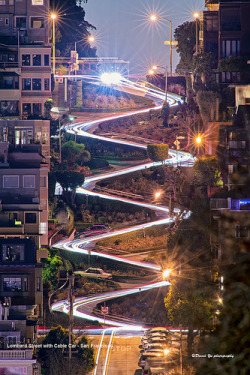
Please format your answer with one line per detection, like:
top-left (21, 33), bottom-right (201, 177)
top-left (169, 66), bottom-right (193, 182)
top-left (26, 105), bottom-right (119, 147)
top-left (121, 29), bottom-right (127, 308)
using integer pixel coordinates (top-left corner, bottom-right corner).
top-left (201, 0), bottom-right (250, 85)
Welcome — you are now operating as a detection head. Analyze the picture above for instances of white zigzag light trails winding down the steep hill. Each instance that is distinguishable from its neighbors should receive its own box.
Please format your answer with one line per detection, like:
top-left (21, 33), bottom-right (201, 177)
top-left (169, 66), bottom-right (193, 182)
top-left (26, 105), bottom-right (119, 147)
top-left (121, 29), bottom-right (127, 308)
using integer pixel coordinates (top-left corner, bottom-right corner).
top-left (52, 76), bottom-right (195, 332)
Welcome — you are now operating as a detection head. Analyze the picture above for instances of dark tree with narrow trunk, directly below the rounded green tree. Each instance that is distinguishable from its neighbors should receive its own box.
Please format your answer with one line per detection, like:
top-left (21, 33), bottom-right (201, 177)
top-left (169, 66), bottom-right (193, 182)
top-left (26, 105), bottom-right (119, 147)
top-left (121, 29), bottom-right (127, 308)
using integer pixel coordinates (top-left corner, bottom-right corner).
top-left (56, 171), bottom-right (84, 205)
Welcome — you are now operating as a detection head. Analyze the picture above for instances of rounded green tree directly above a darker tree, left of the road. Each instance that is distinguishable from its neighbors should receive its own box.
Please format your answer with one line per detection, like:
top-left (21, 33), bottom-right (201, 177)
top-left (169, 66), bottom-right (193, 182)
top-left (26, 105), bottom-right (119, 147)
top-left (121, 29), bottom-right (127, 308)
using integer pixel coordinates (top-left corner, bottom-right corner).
top-left (62, 141), bottom-right (91, 171)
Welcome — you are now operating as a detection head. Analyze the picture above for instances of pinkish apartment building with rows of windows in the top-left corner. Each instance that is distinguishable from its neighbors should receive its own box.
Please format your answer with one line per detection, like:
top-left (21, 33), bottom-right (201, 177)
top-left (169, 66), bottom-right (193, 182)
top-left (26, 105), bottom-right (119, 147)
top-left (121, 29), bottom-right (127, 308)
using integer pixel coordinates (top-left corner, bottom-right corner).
top-left (0, 0), bottom-right (51, 118)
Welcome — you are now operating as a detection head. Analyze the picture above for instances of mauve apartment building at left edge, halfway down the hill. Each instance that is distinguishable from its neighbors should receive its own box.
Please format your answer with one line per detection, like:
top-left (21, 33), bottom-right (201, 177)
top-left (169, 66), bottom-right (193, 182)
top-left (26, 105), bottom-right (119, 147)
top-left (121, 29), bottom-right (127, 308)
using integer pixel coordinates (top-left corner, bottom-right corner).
top-left (0, 142), bottom-right (48, 260)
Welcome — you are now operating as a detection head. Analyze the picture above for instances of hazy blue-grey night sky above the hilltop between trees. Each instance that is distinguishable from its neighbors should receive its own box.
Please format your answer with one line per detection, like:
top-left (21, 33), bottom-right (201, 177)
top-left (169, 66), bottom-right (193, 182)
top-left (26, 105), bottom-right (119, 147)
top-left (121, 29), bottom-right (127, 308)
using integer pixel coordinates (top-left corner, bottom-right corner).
top-left (83, 0), bottom-right (205, 75)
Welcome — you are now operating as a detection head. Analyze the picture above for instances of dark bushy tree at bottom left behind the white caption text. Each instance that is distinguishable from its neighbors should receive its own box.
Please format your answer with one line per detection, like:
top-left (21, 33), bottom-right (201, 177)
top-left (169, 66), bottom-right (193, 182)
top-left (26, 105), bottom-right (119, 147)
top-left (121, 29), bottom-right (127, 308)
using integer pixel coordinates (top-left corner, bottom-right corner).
top-left (38, 326), bottom-right (94, 375)
